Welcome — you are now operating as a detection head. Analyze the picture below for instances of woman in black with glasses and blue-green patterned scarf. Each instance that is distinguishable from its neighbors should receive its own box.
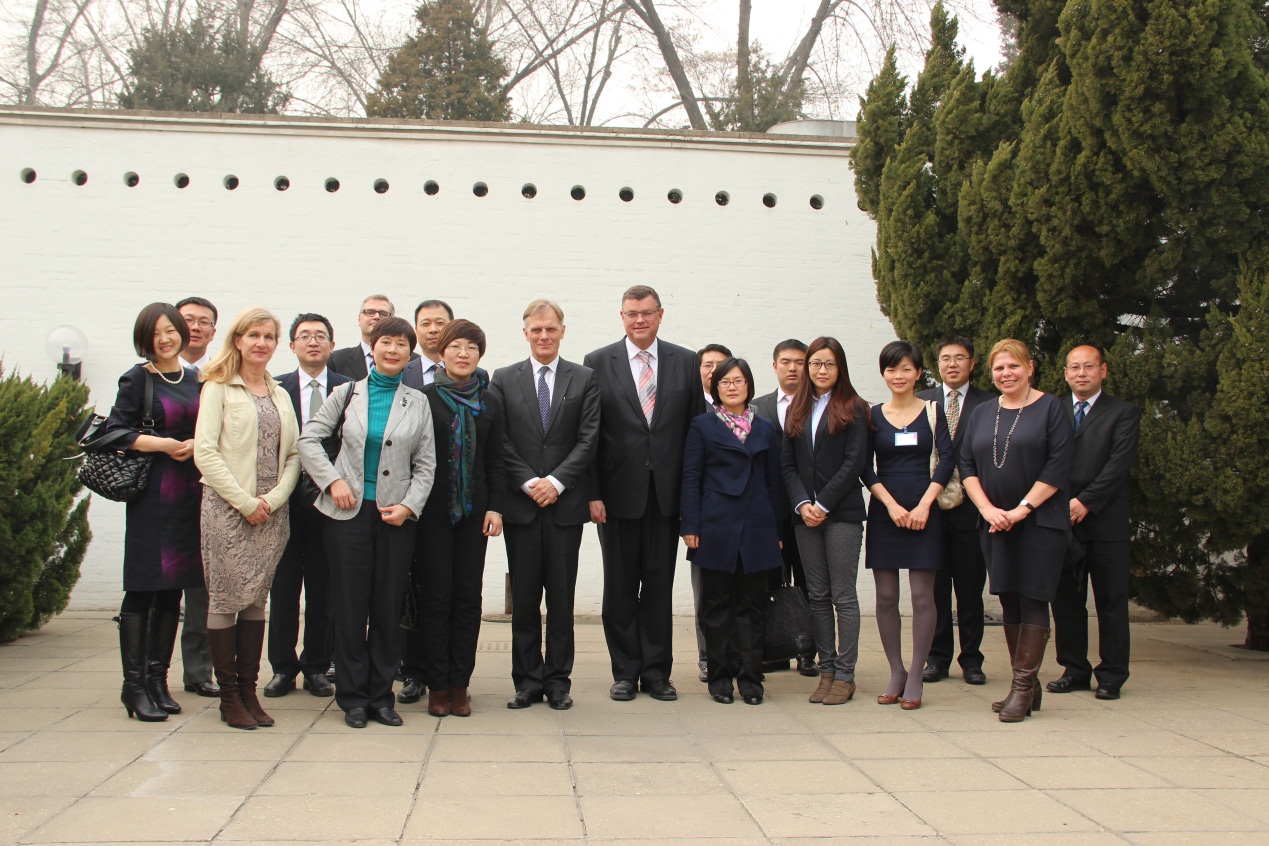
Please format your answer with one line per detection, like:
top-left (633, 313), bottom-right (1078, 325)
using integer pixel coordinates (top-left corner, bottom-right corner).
top-left (414, 320), bottom-right (506, 717)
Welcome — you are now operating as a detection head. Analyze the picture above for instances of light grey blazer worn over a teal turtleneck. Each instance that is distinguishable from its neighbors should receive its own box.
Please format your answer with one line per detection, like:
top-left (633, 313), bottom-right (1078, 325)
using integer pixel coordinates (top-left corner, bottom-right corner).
top-left (299, 379), bottom-right (437, 520)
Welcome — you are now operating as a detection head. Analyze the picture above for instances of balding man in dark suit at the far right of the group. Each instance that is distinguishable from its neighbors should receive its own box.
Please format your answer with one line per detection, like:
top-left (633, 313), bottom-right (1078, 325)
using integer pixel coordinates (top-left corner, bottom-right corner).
top-left (1047, 345), bottom-right (1141, 699)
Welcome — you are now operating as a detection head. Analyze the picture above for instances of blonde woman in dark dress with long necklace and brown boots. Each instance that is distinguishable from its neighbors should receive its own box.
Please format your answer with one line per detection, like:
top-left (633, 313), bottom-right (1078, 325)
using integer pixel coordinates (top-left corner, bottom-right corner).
top-left (961, 339), bottom-right (1075, 723)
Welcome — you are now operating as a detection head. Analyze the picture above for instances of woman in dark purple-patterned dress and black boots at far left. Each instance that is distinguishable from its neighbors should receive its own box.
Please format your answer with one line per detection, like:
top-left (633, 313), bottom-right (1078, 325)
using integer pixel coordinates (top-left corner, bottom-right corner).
top-left (105, 303), bottom-right (203, 722)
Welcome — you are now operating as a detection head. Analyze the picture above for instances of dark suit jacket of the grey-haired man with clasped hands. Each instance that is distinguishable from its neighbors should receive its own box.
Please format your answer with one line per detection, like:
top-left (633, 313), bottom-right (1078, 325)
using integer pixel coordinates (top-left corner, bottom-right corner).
top-left (489, 359), bottom-right (599, 526)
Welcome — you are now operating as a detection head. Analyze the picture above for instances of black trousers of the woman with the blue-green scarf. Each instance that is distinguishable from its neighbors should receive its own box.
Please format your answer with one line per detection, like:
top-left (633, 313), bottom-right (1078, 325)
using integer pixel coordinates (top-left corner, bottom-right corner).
top-left (405, 511), bottom-right (489, 690)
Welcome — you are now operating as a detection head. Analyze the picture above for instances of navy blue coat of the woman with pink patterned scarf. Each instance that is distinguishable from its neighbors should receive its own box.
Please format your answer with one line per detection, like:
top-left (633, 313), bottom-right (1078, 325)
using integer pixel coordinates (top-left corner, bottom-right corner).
top-left (680, 411), bottom-right (784, 573)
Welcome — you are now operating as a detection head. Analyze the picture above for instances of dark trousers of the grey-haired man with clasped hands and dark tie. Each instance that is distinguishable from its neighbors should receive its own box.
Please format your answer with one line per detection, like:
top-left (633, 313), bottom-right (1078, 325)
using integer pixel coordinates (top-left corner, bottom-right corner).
top-left (505, 505), bottom-right (581, 694)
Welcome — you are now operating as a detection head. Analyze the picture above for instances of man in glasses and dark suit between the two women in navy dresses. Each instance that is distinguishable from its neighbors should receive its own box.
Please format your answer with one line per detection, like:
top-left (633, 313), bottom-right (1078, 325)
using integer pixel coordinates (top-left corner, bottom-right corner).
top-left (916, 336), bottom-right (992, 685)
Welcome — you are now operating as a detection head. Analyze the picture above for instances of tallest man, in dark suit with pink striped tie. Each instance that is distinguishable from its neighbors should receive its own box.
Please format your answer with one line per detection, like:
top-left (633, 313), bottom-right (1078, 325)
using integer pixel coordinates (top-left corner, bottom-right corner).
top-left (584, 285), bottom-right (706, 701)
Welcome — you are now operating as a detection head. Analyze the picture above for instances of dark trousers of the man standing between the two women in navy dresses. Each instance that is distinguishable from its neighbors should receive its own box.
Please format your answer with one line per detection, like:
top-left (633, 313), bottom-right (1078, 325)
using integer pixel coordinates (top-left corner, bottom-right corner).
top-left (926, 520), bottom-right (987, 668)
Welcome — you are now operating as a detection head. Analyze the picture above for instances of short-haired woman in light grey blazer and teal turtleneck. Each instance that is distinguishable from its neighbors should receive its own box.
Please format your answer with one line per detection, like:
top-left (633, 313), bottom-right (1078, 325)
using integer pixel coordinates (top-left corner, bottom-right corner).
top-left (299, 317), bottom-right (437, 728)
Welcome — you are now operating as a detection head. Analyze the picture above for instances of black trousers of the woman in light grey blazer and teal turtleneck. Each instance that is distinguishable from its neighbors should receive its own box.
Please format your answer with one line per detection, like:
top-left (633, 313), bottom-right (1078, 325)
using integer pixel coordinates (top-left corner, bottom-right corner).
top-left (326, 502), bottom-right (418, 710)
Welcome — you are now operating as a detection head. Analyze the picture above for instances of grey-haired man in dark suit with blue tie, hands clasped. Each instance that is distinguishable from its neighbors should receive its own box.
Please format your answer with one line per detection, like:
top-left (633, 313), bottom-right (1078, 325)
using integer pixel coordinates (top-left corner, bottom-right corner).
top-left (490, 299), bottom-right (599, 710)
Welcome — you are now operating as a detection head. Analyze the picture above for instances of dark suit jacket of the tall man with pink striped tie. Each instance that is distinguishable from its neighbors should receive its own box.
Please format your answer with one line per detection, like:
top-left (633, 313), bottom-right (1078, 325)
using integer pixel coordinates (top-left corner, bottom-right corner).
top-left (584, 337), bottom-right (706, 520)
